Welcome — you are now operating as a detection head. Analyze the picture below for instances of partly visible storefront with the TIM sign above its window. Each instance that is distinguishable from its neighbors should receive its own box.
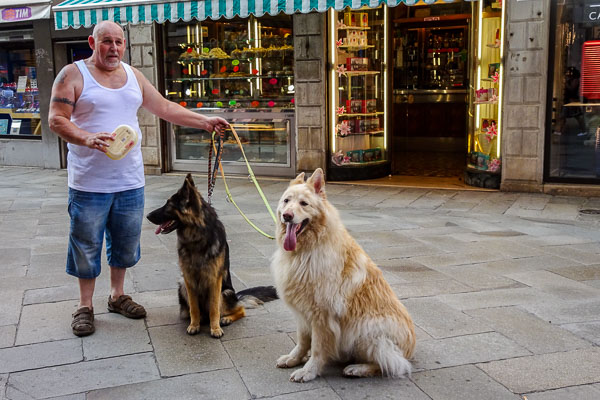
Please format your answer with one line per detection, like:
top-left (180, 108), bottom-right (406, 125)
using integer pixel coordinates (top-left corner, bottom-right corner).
top-left (0, 0), bottom-right (58, 168)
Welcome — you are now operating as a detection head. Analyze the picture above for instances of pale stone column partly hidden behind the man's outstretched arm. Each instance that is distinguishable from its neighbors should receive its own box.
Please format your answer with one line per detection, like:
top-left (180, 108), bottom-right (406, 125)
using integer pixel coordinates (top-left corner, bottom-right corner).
top-left (128, 24), bottom-right (162, 175)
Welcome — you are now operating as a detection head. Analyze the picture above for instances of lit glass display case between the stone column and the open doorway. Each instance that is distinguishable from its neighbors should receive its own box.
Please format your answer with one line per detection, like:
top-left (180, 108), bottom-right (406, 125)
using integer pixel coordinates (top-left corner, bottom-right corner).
top-left (328, 5), bottom-right (389, 180)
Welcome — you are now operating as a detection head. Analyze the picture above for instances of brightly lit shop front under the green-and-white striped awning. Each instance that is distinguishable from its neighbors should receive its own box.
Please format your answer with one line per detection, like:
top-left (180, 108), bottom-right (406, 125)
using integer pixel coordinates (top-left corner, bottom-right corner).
top-left (54, 0), bottom-right (501, 184)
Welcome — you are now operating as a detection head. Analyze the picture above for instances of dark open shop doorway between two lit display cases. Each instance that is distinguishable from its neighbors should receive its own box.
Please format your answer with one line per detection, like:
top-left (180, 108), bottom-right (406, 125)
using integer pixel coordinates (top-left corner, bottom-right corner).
top-left (390, 2), bottom-right (472, 182)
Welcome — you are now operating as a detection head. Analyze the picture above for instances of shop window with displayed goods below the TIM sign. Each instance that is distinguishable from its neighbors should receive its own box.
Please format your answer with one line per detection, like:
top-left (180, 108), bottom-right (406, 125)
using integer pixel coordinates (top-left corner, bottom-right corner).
top-left (0, 30), bottom-right (41, 139)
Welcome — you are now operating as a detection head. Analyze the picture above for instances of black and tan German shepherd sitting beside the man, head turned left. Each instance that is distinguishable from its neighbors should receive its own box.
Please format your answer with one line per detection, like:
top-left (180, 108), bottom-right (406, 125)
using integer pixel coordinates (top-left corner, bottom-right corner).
top-left (146, 174), bottom-right (277, 338)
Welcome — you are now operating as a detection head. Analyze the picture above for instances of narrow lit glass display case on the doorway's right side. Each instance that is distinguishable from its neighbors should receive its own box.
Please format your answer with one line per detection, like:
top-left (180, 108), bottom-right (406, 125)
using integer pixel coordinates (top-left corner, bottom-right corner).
top-left (465, 0), bottom-right (503, 188)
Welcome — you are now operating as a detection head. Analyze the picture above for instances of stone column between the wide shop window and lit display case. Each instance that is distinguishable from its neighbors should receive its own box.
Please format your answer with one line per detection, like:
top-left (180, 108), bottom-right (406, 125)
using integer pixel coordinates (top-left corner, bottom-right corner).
top-left (293, 12), bottom-right (327, 172)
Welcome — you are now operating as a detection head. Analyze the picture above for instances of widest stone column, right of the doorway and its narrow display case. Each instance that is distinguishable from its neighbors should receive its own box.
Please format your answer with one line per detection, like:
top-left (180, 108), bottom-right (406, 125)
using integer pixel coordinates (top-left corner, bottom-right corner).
top-left (500, 0), bottom-right (550, 192)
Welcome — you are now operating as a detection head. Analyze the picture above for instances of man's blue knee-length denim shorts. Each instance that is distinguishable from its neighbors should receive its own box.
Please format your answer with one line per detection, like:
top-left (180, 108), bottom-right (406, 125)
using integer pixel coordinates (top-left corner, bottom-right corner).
top-left (67, 187), bottom-right (144, 279)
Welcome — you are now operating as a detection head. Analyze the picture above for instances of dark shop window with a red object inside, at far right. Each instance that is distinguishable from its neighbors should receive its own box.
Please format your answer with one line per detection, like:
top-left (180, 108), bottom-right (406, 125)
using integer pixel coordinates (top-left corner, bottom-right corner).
top-left (546, 0), bottom-right (600, 181)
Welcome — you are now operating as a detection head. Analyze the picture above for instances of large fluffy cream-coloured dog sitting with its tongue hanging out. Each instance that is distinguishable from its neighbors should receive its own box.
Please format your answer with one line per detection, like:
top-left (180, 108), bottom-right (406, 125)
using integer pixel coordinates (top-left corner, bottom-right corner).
top-left (271, 168), bottom-right (415, 382)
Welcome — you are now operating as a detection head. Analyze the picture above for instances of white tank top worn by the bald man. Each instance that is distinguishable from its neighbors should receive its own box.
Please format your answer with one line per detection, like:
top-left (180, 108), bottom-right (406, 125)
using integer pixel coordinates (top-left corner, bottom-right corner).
top-left (67, 60), bottom-right (144, 193)
